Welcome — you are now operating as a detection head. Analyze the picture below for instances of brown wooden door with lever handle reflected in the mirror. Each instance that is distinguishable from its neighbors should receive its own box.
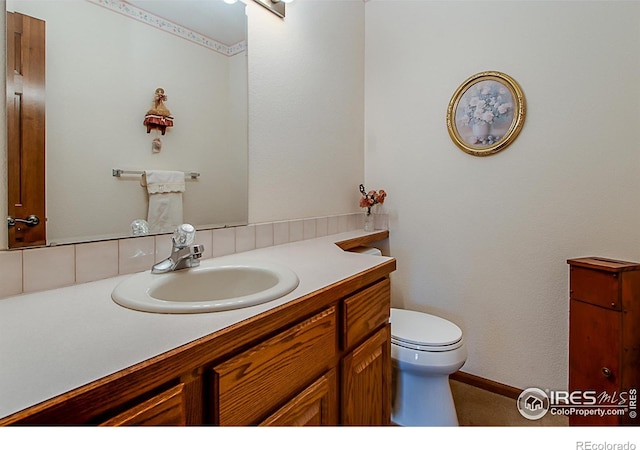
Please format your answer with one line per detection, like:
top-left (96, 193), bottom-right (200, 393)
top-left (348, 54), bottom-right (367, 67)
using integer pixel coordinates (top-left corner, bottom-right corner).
top-left (7, 12), bottom-right (46, 248)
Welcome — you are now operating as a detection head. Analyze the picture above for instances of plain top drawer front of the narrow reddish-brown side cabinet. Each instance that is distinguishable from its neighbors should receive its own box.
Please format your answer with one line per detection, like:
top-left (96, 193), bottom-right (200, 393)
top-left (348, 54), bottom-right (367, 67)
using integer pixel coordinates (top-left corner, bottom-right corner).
top-left (569, 267), bottom-right (621, 310)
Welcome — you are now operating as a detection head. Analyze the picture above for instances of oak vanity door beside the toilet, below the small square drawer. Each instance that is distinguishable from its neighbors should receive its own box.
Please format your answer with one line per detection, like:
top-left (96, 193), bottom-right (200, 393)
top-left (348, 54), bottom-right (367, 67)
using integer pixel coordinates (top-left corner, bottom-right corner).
top-left (341, 324), bottom-right (391, 425)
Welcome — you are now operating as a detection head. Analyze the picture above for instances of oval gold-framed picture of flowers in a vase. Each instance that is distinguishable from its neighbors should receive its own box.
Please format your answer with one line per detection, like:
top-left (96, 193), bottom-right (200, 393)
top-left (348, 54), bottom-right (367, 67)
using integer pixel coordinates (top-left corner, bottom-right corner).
top-left (447, 71), bottom-right (526, 156)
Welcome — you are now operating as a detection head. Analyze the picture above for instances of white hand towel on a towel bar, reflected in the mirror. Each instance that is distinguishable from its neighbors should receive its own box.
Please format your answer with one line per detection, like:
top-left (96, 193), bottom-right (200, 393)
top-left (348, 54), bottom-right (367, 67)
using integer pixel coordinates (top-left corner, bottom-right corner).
top-left (141, 170), bottom-right (185, 233)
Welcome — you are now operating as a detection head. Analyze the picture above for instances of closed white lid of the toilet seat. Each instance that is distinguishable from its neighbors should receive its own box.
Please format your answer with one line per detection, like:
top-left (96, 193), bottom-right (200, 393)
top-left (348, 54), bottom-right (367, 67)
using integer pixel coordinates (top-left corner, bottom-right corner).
top-left (389, 308), bottom-right (462, 347)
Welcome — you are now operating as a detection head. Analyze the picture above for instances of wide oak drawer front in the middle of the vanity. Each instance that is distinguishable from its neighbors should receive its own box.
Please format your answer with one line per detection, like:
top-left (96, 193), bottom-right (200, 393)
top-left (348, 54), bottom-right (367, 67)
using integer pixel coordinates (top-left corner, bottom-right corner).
top-left (213, 306), bottom-right (337, 426)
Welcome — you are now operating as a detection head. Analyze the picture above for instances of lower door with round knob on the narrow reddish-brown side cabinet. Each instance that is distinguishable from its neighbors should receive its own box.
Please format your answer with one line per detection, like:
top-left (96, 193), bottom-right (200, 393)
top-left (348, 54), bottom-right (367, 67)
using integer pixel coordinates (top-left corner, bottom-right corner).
top-left (569, 300), bottom-right (621, 425)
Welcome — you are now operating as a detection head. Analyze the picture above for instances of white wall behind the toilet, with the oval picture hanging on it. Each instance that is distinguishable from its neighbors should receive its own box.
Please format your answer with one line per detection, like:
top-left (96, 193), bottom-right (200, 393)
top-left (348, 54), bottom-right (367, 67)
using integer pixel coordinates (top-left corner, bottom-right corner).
top-left (365, 0), bottom-right (640, 389)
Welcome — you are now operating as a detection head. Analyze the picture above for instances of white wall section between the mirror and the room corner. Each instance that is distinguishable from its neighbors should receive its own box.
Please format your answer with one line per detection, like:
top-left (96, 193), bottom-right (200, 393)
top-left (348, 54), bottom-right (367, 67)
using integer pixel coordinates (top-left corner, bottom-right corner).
top-left (247, 0), bottom-right (364, 223)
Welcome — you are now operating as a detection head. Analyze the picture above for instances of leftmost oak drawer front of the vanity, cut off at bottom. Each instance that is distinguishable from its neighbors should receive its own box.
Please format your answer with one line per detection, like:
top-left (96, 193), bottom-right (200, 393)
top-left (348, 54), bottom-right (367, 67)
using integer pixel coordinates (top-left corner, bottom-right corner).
top-left (100, 383), bottom-right (186, 426)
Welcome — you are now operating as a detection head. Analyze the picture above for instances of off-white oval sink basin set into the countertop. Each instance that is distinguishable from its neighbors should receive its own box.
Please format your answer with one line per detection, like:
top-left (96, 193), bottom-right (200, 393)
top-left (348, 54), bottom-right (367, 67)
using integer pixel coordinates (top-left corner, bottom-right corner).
top-left (111, 260), bottom-right (299, 314)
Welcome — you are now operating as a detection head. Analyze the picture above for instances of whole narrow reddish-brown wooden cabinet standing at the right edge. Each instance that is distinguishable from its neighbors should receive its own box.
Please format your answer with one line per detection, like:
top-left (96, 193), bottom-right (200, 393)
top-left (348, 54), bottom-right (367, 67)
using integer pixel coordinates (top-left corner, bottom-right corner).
top-left (567, 257), bottom-right (640, 426)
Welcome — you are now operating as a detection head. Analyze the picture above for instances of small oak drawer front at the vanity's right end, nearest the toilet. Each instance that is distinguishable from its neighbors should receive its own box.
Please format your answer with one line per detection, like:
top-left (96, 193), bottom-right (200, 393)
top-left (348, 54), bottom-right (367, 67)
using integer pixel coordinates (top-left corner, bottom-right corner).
top-left (342, 278), bottom-right (391, 349)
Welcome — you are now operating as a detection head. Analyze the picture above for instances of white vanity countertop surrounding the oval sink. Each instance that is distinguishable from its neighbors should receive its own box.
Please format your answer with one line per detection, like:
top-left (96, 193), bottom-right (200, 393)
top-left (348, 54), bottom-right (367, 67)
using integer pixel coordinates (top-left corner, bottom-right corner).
top-left (0, 231), bottom-right (390, 418)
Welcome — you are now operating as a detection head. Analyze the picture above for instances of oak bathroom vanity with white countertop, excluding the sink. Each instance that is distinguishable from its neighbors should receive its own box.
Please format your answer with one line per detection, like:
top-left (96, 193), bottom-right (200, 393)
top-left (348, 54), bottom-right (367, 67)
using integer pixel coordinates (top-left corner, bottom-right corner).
top-left (0, 231), bottom-right (396, 426)
